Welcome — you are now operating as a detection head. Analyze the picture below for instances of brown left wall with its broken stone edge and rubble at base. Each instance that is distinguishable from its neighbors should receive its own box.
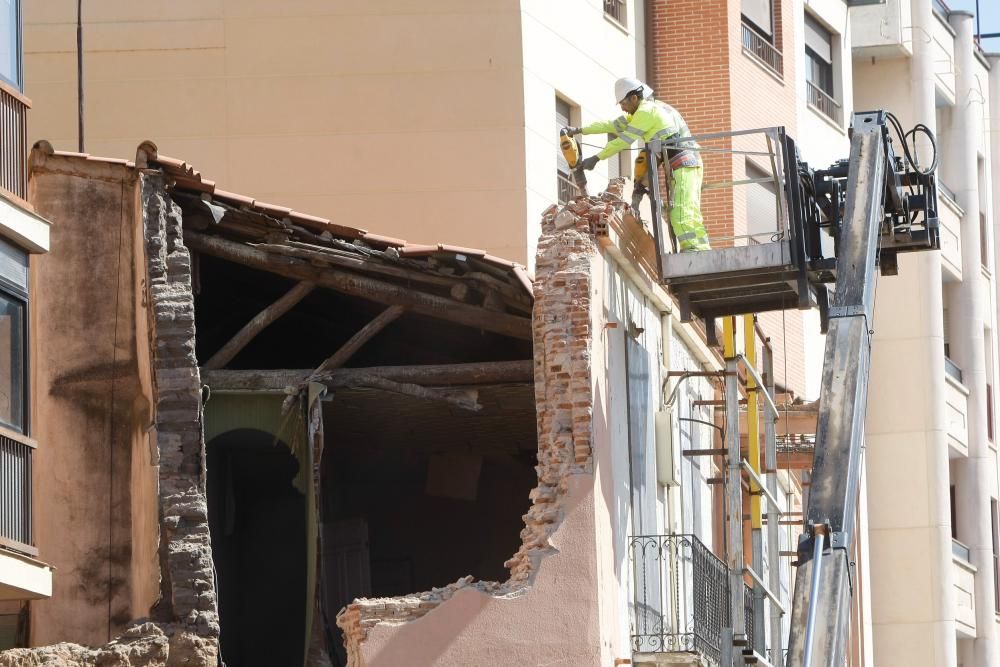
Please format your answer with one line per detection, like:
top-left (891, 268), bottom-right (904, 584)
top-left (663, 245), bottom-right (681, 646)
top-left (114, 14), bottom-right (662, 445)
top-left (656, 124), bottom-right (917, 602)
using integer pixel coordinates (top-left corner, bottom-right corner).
top-left (0, 154), bottom-right (219, 667)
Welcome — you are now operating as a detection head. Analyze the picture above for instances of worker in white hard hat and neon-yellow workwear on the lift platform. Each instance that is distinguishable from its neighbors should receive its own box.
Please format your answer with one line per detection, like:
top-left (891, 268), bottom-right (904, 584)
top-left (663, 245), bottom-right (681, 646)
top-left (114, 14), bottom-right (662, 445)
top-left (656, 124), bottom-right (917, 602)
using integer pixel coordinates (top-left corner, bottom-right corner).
top-left (566, 77), bottom-right (711, 252)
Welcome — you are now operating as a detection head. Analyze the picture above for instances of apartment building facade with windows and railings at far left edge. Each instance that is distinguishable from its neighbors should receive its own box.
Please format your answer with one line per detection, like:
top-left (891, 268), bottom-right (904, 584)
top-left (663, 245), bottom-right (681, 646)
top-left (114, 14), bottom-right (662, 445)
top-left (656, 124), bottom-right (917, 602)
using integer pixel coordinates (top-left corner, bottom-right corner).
top-left (0, 0), bottom-right (52, 649)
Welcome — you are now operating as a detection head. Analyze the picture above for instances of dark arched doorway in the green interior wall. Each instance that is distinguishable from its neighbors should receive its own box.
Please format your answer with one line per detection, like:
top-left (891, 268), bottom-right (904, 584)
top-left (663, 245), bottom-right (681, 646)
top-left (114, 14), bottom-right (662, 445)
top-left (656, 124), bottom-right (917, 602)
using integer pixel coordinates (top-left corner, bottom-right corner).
top-left (207, 429), bottom-right (307, 667)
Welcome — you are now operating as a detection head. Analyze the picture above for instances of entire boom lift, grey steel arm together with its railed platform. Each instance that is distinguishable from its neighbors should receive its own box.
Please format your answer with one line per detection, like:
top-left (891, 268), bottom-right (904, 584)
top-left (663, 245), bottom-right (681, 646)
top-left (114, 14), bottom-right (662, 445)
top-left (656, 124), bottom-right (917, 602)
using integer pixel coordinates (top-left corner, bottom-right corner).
top-left (647, 111), bottom-right (940, 667)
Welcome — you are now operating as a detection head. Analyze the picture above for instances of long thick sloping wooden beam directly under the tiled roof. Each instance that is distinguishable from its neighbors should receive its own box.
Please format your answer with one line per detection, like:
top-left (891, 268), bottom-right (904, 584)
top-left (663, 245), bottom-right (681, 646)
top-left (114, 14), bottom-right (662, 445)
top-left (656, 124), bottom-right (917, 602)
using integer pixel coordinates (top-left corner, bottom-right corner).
top-left (184, 230), bottom-right (531, 340)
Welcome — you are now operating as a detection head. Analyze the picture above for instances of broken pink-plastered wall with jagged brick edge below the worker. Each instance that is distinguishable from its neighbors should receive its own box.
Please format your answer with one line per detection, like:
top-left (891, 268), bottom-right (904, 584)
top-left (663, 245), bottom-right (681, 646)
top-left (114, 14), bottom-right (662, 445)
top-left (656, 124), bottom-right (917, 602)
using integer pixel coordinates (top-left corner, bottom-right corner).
top-left (338, 190), bottom-right (657, 667)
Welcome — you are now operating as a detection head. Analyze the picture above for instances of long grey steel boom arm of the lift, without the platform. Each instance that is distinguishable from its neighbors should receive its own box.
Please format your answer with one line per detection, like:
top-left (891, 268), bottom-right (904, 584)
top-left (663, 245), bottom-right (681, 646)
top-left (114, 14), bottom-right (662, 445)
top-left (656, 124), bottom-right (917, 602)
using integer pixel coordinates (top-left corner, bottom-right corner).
top-left (788, 112), bottom-right (939, 667)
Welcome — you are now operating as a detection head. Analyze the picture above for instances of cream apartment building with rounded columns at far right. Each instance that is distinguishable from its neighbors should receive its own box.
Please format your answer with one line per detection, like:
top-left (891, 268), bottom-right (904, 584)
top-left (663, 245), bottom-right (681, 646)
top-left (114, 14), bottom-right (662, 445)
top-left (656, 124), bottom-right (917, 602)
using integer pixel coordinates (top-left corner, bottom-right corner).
top-left (851, 0), bottom-right (1000, 666)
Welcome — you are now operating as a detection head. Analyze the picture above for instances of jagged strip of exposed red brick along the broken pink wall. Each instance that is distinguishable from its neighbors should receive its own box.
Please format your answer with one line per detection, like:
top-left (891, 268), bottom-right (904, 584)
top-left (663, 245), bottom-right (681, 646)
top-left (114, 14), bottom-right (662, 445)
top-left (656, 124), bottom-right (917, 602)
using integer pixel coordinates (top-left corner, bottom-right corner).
top-left (337, 190), bottom-right (627, 667)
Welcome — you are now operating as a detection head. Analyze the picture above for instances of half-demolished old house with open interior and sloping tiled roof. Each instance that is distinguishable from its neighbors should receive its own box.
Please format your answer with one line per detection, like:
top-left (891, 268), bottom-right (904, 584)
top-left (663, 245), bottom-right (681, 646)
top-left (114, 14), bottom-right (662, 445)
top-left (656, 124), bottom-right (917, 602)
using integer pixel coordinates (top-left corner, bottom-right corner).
top-left (0, 142), bottom-right (801, 667)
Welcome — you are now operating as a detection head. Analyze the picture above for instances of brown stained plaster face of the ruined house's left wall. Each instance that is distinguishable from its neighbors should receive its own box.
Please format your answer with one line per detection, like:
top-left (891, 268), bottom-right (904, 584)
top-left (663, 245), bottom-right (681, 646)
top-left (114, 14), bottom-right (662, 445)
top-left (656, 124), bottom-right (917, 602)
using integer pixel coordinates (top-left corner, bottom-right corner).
top-left (29, 157), bottom-right (159, 645)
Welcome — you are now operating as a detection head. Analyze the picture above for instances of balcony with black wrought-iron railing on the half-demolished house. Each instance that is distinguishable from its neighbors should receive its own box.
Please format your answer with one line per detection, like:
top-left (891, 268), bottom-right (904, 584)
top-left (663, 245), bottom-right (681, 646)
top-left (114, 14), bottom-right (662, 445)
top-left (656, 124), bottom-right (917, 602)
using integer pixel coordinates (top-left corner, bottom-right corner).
top-left (629, 535), bottom-right (753, 664)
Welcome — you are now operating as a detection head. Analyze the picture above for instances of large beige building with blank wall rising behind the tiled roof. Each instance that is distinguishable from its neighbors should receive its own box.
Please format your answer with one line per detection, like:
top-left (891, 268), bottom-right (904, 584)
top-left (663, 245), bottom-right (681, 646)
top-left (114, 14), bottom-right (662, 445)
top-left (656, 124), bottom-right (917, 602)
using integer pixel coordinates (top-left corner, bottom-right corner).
top-left (24, 0), bottom-right (645, 263)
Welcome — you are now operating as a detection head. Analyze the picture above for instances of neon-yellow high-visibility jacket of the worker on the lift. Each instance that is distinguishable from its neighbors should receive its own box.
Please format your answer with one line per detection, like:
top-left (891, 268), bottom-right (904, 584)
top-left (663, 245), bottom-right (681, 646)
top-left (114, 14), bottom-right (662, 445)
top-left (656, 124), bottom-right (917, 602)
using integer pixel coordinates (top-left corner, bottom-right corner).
top-left (580, 99), bottom-right (701, 169)
